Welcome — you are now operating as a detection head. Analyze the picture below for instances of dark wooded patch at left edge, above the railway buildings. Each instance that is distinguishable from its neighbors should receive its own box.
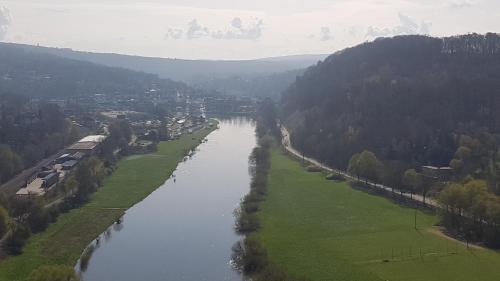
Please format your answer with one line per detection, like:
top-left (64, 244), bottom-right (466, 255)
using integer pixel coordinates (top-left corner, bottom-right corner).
top-left (0, 94), bottom-right (80, 183)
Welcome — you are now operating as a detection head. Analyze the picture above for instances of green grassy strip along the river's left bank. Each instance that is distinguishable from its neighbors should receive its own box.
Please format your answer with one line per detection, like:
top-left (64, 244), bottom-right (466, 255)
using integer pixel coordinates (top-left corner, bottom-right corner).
top-left (0, 124), bottom-right (217, 281)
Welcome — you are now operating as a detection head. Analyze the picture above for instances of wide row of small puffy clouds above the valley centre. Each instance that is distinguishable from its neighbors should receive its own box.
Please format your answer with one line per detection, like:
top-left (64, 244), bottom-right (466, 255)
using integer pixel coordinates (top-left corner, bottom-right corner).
top-left (165, 17), bottom-right (264, 40)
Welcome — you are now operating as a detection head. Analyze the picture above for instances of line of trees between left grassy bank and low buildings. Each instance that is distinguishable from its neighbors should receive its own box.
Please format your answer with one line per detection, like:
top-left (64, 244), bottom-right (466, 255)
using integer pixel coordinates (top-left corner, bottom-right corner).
top-left (0, 120), bottom-right (132, 255)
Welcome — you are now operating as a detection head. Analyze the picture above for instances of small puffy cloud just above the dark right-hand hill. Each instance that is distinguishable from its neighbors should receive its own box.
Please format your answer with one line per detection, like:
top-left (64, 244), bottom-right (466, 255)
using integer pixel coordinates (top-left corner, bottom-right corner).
top-left (365, 13), bottom-right (432, 38)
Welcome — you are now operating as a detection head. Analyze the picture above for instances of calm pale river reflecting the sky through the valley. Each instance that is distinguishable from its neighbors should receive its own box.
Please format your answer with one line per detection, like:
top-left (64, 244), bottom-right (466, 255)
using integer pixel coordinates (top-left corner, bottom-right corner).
top-left (76, 117), bottom-right (256, 281)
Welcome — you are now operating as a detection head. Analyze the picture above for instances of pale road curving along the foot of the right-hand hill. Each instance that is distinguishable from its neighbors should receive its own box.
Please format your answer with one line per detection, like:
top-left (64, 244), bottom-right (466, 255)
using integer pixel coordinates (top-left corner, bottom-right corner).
top-left (281, 126), bottom-right (441, 208)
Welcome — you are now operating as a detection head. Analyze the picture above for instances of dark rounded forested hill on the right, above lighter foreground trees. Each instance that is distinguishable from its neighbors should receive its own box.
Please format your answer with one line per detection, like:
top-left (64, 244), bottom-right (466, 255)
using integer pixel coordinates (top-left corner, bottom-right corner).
top-left (282, 34), bottom-right (500, 175)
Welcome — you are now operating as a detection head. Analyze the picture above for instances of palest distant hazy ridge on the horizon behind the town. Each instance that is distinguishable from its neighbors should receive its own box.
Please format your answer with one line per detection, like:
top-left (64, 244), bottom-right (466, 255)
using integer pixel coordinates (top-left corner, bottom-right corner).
top-left (6, 44), bottom-right (326, 97)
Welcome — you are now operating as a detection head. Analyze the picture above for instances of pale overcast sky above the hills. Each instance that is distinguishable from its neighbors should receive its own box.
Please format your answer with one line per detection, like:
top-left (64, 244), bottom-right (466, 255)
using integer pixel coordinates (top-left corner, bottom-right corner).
top-left (0, 0), bottom-right (500, 59)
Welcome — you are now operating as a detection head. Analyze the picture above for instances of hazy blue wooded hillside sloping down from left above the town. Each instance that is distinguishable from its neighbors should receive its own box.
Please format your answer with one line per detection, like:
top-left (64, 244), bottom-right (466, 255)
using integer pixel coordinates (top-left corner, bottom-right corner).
top-left (0, 43), bottom-right (189, 97)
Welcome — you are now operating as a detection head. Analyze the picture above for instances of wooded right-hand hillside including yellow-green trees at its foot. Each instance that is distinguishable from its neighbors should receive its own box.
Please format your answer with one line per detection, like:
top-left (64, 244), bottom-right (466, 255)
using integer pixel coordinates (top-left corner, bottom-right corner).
top-left (280, 33), bottom-right (500, 247)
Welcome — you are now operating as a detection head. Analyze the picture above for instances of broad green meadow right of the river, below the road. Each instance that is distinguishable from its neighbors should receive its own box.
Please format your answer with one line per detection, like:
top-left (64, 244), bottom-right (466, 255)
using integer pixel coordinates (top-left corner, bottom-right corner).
top-left (256, 150), bottom-right (500, 281)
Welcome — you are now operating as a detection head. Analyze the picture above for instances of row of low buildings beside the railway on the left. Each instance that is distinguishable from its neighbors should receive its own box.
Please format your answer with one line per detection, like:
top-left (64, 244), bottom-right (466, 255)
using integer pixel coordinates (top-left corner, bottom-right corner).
top-left (16, 135), bottom-right (106, 196)
